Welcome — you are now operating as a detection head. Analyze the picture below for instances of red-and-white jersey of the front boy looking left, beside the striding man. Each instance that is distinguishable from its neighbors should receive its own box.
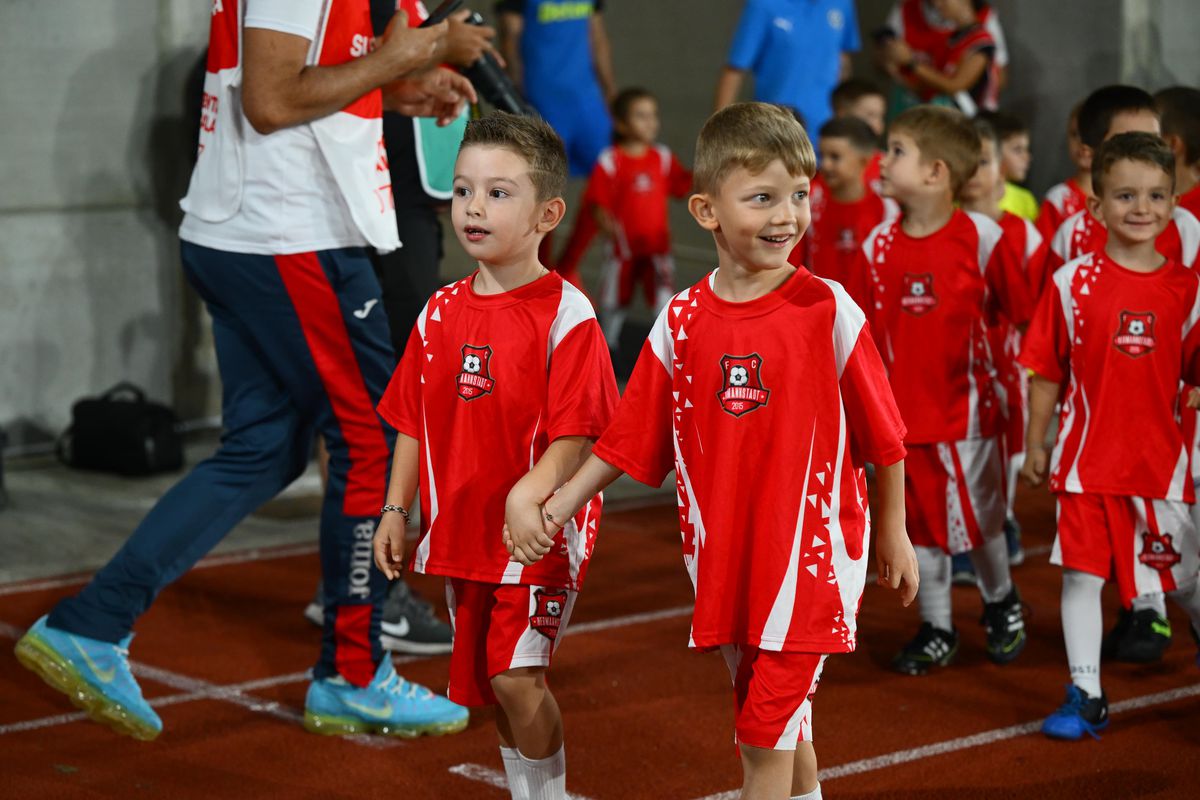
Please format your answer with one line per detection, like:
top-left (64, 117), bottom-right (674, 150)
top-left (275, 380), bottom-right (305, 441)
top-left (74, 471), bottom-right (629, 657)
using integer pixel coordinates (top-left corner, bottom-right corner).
top-left (379, 273), bottom-right (617, 589)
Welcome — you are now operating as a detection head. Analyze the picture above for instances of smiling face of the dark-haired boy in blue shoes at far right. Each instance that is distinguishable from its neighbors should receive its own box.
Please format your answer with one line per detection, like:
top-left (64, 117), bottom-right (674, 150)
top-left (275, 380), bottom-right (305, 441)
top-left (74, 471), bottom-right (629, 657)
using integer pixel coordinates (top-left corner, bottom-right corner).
top-left (1092, 158), bottom-right (1175, 246)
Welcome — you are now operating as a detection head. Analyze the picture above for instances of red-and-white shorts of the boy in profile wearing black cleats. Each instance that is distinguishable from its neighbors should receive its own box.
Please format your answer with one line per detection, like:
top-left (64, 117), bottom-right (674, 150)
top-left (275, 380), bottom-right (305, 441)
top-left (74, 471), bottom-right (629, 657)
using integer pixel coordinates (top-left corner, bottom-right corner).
top-left (904, 437), bottom-right (1007, 555)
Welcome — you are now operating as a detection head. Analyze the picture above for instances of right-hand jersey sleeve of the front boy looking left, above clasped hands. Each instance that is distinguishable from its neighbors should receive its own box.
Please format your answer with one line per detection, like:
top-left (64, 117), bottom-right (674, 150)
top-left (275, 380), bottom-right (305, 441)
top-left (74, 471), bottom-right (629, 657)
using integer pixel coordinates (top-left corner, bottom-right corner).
top-left (546, 317), bottom-right (617, 441)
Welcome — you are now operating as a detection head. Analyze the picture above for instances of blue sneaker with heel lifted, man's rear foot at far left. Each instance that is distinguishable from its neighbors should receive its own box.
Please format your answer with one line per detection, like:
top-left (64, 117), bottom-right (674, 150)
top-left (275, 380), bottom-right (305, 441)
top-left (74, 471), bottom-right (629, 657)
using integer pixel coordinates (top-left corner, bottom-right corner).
top-left (16, 616), bottom-right (162, 741)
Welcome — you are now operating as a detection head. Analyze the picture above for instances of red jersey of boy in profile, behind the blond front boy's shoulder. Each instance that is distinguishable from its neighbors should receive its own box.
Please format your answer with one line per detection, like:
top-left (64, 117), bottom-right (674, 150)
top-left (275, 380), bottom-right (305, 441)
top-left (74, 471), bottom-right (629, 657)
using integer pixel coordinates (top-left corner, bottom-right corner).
top-left (862, 211), bottom-right (1030, 444)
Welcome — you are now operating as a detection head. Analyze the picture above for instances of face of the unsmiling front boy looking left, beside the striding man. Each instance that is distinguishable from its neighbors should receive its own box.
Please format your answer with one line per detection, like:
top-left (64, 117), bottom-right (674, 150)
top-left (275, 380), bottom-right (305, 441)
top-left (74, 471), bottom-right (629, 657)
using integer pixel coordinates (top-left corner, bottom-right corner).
top-left (450, 145), bottom-right (563, 266)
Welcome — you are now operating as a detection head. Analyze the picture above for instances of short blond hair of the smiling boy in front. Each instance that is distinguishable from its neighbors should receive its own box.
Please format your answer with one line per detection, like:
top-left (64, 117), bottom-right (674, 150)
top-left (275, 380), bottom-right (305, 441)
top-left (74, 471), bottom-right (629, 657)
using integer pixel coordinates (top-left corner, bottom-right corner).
top-left (694, 103), bottom-right (817, 194)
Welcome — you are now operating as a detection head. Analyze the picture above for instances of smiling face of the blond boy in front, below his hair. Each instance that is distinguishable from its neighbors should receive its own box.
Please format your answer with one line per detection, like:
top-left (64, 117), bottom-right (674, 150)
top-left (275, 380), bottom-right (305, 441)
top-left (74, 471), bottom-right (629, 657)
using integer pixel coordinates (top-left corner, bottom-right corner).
top-left (688, 158), bottom-right (810, 272)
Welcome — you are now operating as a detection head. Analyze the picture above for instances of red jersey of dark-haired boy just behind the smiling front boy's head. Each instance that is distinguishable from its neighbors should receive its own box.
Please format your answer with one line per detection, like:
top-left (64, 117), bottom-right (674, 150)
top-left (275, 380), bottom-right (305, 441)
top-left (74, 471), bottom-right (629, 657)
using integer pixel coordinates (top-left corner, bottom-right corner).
top-left (788, 181), bottom-right (900, 306)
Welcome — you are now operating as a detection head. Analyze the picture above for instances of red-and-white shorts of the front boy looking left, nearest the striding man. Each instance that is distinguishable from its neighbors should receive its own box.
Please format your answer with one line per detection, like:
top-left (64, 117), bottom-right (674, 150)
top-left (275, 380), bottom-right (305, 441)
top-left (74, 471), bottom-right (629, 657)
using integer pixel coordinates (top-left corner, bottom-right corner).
top-left (446, 578), bottom-right (578, 705)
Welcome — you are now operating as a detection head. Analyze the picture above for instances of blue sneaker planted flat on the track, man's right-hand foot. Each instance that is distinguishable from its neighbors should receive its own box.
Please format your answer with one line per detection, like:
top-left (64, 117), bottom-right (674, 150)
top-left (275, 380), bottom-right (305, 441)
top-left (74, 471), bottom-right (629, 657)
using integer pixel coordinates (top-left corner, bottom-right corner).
top-left (304, 656), bottom-right (470, 739)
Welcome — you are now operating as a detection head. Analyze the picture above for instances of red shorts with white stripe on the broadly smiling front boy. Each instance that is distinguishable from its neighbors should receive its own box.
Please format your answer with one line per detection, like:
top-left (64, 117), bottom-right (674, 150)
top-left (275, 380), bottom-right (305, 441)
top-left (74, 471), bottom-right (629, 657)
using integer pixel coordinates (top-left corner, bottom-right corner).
top-left (721, 644), bottom-right (826, 750)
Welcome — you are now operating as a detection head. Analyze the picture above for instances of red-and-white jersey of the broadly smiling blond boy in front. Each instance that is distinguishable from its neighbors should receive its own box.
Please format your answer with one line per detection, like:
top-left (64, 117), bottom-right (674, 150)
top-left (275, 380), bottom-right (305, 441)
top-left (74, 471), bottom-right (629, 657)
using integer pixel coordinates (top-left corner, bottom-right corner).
top-left (593, 269), bottom-right (905, 652)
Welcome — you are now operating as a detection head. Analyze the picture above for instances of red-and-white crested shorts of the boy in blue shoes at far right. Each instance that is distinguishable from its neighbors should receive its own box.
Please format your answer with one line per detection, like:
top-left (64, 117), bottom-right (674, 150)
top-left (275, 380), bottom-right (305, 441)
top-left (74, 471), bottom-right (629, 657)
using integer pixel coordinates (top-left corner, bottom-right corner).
top-left (1050, 493), bottom-right (1200, 607)
